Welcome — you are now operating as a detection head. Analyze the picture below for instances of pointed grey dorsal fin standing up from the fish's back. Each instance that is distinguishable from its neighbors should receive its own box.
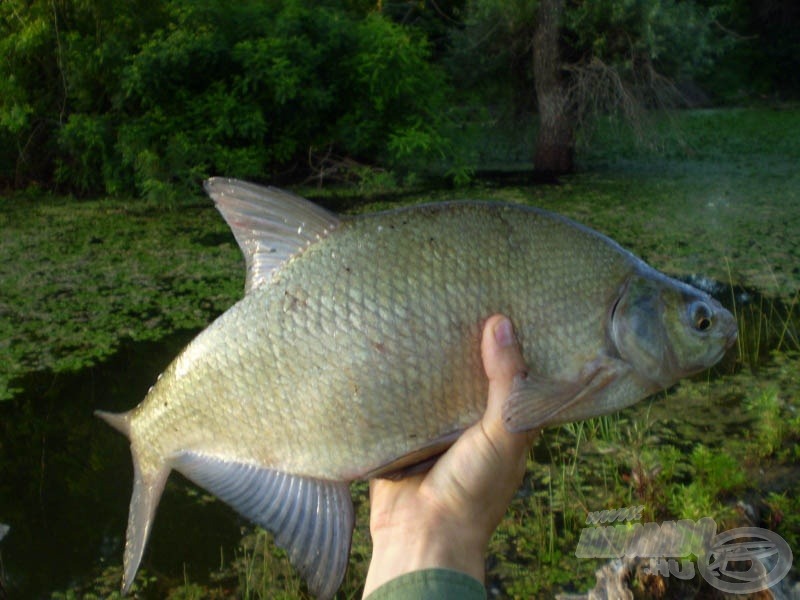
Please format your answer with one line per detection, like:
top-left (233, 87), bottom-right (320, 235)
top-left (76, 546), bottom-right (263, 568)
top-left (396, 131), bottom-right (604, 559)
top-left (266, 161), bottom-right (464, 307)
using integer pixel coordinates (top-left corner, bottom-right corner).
top-left (205, 177), bottom-right (339, 294)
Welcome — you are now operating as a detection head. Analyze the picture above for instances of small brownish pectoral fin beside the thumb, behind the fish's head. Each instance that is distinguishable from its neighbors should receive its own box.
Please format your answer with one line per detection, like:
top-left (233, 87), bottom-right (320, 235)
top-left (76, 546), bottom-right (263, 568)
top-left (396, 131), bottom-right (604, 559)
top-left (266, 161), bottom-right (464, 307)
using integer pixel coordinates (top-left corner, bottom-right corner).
top-left (503, 357), bottom-right (630, 433)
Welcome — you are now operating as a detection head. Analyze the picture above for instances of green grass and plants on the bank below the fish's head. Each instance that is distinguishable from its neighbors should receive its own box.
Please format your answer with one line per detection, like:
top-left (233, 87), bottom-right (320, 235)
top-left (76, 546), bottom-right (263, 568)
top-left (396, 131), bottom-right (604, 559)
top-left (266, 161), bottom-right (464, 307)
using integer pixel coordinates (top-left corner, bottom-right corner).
top-left (482, 358), bottom-right (800, 598)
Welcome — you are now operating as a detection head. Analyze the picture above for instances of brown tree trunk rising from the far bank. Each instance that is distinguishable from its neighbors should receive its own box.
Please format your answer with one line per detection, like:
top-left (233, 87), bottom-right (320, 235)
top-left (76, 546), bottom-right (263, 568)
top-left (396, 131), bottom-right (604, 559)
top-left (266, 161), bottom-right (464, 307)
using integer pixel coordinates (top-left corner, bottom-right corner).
top-left (533, 0), bottom-right (575, 176)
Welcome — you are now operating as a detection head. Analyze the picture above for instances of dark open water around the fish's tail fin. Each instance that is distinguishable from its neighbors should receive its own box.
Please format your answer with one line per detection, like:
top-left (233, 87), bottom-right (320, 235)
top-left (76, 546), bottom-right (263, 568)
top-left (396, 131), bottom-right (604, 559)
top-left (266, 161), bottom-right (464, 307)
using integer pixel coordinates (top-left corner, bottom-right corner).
top-left (0, 332), bottom-right (240, 598)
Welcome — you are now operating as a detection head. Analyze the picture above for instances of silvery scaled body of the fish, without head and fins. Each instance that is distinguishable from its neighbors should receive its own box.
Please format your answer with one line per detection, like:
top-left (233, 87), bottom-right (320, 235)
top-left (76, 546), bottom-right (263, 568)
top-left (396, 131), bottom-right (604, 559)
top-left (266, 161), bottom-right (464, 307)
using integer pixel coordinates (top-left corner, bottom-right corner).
top-left (131, 204), bottom-right (636, 479)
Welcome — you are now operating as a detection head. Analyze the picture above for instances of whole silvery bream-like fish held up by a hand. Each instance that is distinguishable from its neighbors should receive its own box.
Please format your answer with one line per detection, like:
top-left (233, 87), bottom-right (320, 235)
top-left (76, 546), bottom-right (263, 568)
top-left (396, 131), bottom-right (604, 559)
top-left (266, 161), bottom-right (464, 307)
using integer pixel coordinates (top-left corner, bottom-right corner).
top-left (96, 178), bottom-right (737, 598)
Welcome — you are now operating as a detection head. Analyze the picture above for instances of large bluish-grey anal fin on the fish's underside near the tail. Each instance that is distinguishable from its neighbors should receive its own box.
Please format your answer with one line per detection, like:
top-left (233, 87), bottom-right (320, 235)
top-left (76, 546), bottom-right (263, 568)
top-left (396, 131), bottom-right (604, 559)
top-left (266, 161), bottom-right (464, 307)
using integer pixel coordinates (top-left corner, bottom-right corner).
top-left (173, 452), bottom-right (354, 598)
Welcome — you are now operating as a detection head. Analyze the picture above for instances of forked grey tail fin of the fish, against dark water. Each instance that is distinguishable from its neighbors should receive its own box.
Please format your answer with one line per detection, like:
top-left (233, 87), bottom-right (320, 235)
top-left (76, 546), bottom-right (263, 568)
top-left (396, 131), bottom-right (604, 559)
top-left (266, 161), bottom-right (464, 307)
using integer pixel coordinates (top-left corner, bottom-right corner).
top-left (94, 410), bottom-right (170, 595)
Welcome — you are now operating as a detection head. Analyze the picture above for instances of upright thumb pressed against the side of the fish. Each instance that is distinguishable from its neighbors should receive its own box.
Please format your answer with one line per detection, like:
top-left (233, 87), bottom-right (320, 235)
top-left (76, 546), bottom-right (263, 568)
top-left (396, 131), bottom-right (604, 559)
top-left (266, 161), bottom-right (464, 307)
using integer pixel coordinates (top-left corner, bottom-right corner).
top-left (481, 315), bottom-right (537, 455)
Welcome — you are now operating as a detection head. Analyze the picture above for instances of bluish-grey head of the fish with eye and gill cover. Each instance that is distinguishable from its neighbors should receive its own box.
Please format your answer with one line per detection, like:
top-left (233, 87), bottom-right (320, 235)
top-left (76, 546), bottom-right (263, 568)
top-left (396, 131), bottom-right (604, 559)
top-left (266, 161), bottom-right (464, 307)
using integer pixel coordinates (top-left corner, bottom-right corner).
top-left (610, 272), bottom-right (737, 390)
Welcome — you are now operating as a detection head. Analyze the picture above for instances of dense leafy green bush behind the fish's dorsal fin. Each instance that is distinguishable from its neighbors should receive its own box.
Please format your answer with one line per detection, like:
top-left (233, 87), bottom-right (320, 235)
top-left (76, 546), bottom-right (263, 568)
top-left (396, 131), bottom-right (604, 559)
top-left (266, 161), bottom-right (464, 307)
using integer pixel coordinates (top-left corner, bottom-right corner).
top-left (120, 2), bottom-right (462, 197)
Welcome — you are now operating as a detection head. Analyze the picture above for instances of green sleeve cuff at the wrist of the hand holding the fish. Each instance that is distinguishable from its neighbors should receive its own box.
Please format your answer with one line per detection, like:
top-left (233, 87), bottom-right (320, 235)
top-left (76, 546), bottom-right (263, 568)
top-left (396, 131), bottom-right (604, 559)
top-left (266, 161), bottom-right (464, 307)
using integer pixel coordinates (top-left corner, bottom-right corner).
top-left (366, 569), bottom-right (486, 600)
